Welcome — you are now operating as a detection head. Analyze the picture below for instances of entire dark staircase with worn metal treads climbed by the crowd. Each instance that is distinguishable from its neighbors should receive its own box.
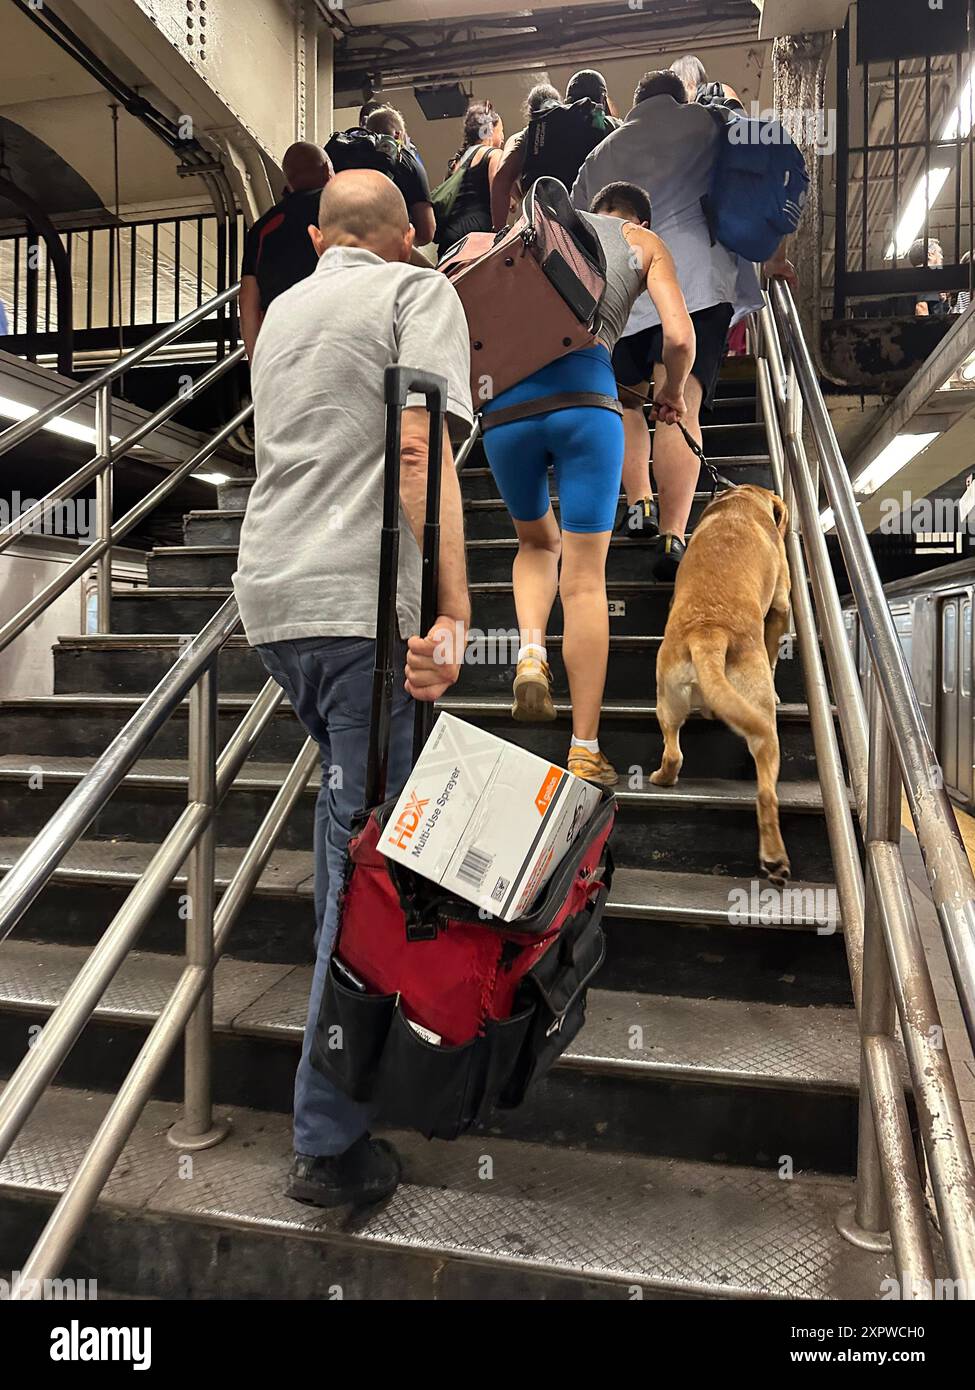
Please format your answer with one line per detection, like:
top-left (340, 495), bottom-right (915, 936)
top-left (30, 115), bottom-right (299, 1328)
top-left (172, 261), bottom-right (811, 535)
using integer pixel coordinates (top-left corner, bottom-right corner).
top-left (0, 360), bottom-right (890, 1300)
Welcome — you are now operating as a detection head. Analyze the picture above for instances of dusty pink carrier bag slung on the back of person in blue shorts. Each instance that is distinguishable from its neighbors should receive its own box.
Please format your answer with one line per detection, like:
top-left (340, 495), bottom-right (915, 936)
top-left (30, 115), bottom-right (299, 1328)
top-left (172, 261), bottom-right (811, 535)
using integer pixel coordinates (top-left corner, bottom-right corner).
top-left (437, 178), bottom-right (606, 404)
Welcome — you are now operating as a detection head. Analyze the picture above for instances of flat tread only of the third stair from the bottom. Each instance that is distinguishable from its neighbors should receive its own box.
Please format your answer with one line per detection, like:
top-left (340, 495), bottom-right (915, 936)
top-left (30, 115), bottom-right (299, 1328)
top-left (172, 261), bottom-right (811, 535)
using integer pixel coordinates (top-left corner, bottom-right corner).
top-left (0, 835), bottom-right (835, 930)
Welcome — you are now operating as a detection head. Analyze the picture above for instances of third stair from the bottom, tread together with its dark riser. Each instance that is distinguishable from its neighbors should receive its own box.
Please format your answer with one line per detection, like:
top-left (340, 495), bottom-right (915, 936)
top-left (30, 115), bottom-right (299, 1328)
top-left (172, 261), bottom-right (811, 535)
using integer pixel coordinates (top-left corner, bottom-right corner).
top-left (0, 835), bottom-right (850, 1006)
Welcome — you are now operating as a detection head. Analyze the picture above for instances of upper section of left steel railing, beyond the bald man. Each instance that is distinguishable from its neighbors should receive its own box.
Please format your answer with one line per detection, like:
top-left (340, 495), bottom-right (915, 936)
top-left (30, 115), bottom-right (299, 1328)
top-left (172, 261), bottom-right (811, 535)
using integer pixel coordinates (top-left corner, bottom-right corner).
top-left (0, 285), bottom-right (243, 652)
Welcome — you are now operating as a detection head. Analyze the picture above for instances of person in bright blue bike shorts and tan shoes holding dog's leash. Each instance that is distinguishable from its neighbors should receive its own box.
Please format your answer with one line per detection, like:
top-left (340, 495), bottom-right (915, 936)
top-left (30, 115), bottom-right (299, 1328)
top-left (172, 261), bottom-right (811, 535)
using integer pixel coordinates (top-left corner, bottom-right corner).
top-left (483, 183), bottom-right (694, 787)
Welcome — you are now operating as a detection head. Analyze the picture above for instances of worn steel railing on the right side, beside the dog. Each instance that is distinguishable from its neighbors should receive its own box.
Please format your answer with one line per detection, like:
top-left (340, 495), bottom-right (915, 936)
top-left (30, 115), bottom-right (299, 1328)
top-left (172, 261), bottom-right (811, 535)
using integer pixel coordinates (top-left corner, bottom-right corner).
top-left (758, 282), bottom-right (975, 1298)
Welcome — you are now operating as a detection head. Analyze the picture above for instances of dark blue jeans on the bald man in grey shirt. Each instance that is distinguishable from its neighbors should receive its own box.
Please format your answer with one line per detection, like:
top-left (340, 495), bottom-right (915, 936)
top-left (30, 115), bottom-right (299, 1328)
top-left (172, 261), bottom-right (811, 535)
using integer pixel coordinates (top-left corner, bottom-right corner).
top-left (257, 637), bottom-right (413, 1155)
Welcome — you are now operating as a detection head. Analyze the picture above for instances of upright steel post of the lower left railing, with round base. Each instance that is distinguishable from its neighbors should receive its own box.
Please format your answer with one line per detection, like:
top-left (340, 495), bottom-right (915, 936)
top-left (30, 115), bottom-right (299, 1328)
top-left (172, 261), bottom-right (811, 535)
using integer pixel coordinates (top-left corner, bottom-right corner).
top-left (168, 657), bottom-right (229, 1151)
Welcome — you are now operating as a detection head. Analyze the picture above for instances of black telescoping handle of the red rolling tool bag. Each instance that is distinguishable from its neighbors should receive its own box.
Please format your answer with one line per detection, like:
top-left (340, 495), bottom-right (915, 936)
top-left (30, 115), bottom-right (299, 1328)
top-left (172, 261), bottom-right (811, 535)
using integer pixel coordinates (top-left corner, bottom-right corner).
top-left (366, 367), bottom-right (446, 810)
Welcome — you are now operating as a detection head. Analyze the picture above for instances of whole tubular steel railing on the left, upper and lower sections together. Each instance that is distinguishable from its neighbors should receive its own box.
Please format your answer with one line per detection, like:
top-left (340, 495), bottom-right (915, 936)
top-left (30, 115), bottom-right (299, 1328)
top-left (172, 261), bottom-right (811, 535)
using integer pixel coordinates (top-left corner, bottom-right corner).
top-left (0, 288), bottom-right (320, 1298)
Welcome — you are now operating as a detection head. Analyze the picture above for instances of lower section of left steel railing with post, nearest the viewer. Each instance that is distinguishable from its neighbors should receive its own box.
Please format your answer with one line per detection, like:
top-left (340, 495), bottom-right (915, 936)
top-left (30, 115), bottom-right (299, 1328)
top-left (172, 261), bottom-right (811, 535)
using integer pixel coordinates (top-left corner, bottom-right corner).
top-left (0, 583), bottom-right (320, 1298)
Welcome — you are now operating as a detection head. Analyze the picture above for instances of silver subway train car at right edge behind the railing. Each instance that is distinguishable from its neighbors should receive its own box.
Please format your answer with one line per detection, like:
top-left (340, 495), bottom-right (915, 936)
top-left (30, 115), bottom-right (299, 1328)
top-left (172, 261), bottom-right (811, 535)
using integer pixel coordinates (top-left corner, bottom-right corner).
top-left (843, 557), bottom-right (975, 813)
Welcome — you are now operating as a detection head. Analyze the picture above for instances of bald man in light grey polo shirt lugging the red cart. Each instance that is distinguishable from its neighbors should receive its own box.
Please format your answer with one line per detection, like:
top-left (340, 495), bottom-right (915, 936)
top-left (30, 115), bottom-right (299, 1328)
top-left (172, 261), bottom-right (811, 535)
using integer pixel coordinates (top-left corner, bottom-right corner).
top-left (234, 170), bottom-right (473, 1207)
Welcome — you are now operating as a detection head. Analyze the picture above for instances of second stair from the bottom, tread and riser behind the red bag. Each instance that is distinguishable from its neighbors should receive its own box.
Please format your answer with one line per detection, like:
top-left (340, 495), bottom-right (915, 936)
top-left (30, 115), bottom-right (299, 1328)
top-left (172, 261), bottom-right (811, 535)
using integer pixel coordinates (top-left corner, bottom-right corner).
top-left (0, 941), bottom-right (860, 1172)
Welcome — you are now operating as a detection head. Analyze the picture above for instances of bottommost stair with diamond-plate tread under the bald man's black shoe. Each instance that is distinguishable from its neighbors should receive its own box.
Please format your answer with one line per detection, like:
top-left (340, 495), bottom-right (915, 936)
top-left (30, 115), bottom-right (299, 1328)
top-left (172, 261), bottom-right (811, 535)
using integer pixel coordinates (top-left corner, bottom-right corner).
top-left (0, 1088), bottom-right (893, 1301)
